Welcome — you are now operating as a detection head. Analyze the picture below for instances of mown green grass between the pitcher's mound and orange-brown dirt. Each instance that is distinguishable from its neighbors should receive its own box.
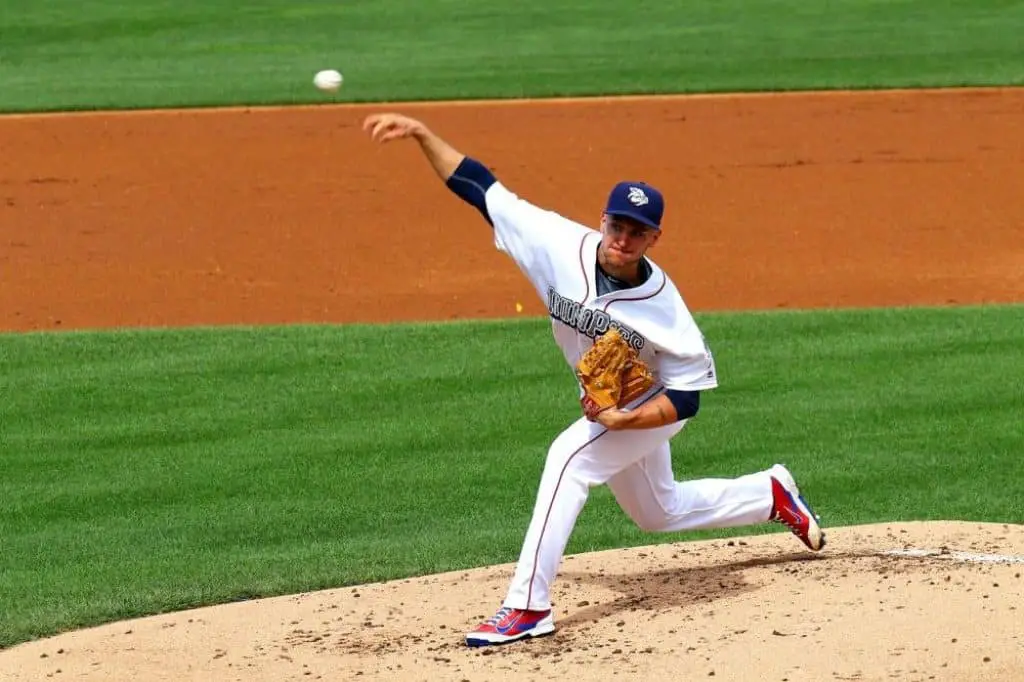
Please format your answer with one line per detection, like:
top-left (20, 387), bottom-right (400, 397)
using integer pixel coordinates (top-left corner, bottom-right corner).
top-left (0, 306), bottom-right (1024, 646)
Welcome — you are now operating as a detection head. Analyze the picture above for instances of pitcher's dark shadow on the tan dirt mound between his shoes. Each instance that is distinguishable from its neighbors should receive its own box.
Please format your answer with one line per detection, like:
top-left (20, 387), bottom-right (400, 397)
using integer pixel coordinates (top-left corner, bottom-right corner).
top-left (558, 552), bottom-right (848, 630)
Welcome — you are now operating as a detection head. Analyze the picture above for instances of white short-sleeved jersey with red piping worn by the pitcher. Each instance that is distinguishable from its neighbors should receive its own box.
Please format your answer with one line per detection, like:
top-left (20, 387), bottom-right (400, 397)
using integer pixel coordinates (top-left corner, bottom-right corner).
top-left (485, 182), bottom-right (718, 391)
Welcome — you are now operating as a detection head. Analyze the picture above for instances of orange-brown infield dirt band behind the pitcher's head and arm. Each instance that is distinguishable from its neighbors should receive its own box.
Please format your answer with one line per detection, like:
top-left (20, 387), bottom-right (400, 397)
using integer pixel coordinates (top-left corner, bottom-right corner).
top-left (0, 89), bottom-right (1024, 330)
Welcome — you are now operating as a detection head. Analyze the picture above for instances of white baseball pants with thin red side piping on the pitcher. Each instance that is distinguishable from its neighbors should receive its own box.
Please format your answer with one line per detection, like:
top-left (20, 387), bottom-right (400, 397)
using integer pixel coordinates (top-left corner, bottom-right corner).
top-left (504, 417), bottom-right (772, 610)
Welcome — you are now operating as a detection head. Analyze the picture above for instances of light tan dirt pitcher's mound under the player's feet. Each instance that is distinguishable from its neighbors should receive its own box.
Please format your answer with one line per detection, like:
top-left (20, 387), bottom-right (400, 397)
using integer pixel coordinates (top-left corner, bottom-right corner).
top-left (0, 522), bottom-right (1024, 682)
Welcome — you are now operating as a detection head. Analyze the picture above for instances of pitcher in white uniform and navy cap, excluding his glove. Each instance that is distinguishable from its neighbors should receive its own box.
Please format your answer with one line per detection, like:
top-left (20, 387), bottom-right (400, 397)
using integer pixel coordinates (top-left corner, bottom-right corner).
top-left (364, 113), bottom-right (825, 646)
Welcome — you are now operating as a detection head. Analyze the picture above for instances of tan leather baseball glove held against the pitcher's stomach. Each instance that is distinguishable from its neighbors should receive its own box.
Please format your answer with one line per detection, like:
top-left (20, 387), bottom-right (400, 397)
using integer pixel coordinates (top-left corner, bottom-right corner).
top-left (577, 328), bottom-right (654, 421)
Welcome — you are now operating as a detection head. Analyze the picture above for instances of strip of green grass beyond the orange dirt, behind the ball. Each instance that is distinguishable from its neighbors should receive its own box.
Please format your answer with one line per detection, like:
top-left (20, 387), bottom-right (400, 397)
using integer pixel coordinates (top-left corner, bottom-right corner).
top-left (0, 0), bottom-right (1024, 111)
